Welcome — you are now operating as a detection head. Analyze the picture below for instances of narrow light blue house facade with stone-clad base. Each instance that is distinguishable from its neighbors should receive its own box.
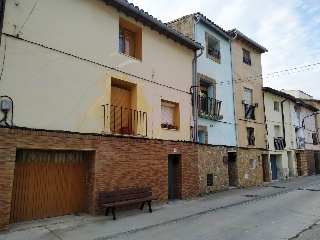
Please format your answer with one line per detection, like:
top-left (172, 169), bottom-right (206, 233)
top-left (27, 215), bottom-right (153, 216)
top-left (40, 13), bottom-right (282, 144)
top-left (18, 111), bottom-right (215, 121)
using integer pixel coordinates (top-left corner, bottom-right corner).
top-left (168, 13), bottom-right (237, 194)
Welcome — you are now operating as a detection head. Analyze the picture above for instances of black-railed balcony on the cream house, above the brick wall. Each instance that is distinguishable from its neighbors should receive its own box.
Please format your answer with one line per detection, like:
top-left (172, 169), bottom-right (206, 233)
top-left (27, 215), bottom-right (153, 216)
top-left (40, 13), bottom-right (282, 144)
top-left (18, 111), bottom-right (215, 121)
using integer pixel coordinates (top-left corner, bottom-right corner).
top-left (102, 104), bottom-right (148, 137)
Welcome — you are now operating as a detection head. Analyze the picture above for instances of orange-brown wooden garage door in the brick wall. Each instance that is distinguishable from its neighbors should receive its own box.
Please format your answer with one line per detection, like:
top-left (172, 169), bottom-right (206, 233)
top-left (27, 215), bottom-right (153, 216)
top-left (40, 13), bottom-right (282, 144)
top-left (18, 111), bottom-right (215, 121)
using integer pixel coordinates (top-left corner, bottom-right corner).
top-left (10, 150), bottom-right (86, 222)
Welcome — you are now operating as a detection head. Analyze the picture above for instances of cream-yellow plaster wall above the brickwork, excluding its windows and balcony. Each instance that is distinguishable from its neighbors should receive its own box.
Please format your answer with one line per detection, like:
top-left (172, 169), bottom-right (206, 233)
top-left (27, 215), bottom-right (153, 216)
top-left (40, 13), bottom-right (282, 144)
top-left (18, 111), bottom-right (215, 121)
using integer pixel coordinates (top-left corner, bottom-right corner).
top-left (0, 0), bottom-right (193, 140)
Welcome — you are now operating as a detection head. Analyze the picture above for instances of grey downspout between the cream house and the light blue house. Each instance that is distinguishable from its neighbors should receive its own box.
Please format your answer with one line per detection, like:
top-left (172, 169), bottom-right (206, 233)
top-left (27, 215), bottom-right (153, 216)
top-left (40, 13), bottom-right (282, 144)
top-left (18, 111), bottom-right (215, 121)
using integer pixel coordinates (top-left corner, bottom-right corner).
top-left (192, 15), bottom-right (203, 142)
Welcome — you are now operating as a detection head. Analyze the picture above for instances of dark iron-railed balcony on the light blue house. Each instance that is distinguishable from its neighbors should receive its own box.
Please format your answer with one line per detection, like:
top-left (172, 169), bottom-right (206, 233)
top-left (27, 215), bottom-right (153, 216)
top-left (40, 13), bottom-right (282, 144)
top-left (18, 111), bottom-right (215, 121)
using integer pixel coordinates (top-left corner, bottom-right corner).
top-left (198, 95), bottom-right (223, 120)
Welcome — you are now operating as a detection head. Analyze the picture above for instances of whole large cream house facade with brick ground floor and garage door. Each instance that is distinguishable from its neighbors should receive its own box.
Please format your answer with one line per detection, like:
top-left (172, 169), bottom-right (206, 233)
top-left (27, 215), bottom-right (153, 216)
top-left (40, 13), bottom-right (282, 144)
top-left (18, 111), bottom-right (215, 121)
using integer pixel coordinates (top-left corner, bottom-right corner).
top-left (0, 0), bottom-right (201, 231)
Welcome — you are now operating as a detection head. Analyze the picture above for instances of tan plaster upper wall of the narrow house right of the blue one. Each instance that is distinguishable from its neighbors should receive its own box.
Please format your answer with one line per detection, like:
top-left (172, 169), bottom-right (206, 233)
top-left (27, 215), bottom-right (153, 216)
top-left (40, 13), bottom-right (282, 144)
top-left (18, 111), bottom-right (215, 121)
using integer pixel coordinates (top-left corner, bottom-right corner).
top-left (231, 38), bottom-right (266, 148)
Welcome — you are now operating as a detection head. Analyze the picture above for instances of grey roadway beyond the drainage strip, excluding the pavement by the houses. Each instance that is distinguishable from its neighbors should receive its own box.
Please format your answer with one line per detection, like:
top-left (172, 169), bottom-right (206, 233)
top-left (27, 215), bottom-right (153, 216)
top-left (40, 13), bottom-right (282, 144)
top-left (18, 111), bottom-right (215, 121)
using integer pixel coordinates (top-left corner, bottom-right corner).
top-left (111, 181), bottom-right (320, 240)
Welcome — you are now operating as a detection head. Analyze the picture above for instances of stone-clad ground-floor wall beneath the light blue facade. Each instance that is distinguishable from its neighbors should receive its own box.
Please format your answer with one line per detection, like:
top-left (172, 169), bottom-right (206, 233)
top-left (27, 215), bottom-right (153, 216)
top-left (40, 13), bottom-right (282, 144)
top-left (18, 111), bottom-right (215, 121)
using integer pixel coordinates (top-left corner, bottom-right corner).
top-left (198, 145), bottom-right (229, 195)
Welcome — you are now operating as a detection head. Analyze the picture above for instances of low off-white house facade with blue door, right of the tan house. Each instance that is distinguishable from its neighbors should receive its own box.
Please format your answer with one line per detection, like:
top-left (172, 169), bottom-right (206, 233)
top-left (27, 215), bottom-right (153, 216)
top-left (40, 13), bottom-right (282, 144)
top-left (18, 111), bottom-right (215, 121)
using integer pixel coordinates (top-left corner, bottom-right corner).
top-left (263, 87), bottom-right (300, 180)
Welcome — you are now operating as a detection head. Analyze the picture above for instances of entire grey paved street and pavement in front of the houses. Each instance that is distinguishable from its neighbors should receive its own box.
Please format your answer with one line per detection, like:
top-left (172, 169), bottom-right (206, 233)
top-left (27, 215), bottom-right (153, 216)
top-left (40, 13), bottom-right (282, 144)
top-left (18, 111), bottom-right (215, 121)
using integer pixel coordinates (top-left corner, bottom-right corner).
top-left (0, 176), bottom-right (320, 240)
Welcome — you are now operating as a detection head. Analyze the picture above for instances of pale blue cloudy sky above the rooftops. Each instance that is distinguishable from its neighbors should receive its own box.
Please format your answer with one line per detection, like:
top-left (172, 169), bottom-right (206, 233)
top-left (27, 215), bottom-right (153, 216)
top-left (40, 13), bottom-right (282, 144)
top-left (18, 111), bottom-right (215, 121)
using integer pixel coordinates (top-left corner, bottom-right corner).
top-left (128, 0), bottom-right (320, 99)
